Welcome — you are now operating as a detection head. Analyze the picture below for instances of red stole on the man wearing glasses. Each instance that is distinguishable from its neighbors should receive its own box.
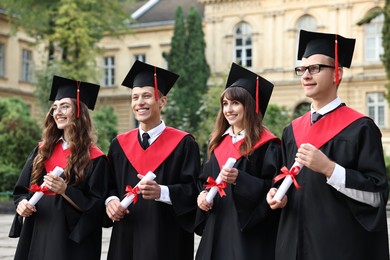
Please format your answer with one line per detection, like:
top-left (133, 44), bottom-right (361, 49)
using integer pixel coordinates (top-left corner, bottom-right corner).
top-left (292, 106), bottom-right (365, 148)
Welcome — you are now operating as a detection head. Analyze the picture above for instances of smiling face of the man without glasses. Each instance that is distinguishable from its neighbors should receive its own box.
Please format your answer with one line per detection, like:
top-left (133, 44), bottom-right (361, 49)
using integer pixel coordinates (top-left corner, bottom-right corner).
top-left (131, 87), bottom-right (166, 131)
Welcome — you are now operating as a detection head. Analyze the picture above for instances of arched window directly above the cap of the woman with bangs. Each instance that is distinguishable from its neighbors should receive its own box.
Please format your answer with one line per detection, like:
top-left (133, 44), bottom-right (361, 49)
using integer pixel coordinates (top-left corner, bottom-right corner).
top-left (233, 23), bottom-right (252, 67)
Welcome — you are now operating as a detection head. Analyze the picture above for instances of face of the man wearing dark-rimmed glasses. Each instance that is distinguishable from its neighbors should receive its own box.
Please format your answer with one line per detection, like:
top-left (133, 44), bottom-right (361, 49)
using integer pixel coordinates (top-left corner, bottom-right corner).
top-left (301, 54), bottom-right (342, 110)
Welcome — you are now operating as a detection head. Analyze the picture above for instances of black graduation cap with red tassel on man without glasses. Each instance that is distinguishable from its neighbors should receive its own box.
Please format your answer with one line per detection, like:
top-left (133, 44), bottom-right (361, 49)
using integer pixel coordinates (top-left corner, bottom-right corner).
top-left (122, 60), bottom-right (179, 101)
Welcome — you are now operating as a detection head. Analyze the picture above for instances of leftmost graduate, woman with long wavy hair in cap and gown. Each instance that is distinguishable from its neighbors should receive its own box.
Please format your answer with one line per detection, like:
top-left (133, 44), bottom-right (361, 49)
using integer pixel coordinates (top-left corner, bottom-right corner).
top-left (10, 76), bottom-right (109, 260)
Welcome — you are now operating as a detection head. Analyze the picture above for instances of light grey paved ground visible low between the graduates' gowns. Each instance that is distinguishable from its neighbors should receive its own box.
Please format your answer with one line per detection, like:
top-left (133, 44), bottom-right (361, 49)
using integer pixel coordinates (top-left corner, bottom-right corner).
top-left (0, 211), bottom-right (390, 260)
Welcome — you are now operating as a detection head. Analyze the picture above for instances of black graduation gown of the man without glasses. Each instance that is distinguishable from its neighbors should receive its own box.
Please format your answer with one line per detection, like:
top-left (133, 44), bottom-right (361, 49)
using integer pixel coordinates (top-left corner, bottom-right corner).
top-left (108, 135), bottom-right (200, 260)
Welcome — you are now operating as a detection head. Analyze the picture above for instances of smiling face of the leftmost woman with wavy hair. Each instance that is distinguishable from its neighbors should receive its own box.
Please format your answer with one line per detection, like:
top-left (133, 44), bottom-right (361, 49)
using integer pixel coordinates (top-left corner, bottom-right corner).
top-left (51, 98), bottom-right (75, 130)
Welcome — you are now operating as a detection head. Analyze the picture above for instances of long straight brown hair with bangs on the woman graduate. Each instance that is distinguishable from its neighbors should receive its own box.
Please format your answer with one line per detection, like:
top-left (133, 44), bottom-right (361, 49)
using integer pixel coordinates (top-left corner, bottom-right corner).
top-left (208, 87), bottom-right (264, 158)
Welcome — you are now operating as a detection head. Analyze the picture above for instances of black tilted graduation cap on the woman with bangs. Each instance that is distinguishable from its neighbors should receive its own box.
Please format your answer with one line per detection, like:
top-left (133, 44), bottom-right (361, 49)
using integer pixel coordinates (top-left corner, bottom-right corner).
top-left (226, 62), bottom-right (274, 117)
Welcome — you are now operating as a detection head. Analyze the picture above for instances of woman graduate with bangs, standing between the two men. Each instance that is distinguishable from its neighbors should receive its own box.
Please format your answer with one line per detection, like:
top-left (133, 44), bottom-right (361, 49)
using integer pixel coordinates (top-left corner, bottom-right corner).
top-left (196, 63), bottom-right (281, 259)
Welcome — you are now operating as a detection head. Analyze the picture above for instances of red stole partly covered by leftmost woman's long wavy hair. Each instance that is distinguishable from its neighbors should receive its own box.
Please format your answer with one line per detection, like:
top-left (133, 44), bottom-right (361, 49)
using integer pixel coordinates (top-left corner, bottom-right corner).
top-left (39, 142), bottom-right (104, 172)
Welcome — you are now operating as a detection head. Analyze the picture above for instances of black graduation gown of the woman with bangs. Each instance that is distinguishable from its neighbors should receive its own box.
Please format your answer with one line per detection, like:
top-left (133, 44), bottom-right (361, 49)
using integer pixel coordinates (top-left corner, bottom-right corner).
top-left (196, 137), bottom-right (281, 260)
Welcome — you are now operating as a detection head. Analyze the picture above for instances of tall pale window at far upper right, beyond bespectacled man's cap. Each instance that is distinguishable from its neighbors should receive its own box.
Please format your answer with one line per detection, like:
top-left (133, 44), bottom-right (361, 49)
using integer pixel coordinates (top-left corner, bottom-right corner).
top-left (364, 14), bottom-right (384, 62)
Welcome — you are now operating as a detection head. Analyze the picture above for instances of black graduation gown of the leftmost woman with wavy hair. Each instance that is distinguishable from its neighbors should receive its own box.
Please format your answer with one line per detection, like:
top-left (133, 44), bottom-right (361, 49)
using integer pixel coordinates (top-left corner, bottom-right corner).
top-left (10, 145), bottom-right (109, 260)
